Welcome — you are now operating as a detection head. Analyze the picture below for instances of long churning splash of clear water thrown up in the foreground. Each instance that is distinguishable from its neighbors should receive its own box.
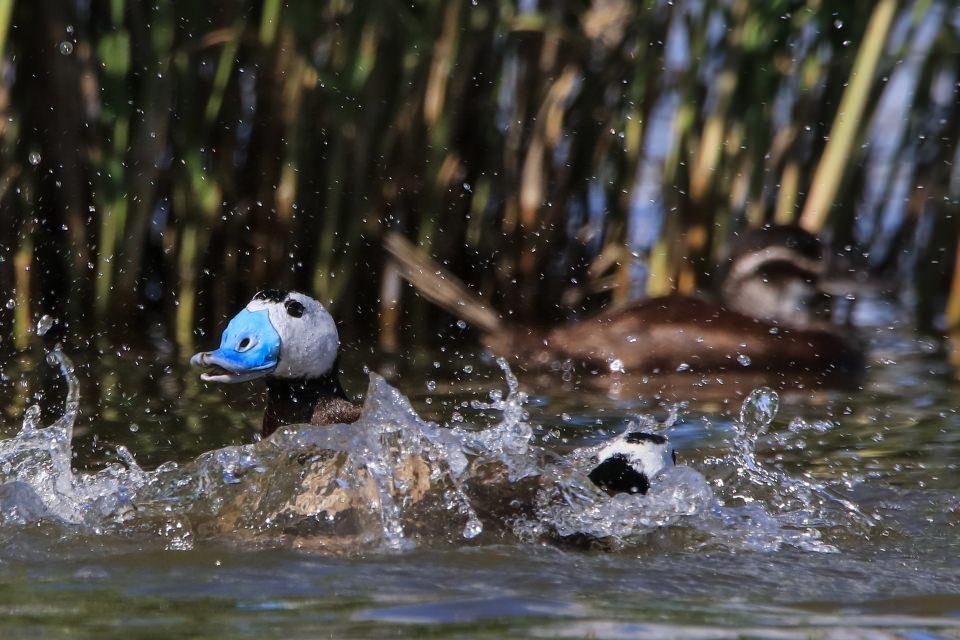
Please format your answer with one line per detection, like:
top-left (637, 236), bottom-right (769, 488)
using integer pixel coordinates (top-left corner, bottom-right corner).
top-left (0, 346), bottom-right (873, 552)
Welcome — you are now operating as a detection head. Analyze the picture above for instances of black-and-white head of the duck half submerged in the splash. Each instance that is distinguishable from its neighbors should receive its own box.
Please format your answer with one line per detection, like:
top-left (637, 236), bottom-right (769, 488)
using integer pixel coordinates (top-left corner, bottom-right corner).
top-left (588, 431), bottom-right (677, 496)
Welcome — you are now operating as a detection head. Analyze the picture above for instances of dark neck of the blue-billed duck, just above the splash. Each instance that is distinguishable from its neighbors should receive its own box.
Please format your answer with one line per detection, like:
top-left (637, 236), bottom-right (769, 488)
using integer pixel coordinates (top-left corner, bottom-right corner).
top-left (263, 366), bottom-right (347, 437)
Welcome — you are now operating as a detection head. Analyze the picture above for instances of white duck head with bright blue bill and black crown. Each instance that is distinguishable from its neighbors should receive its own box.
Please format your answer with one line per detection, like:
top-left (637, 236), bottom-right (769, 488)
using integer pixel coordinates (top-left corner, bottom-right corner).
top-left (190, 289), bottom-right (340, 383)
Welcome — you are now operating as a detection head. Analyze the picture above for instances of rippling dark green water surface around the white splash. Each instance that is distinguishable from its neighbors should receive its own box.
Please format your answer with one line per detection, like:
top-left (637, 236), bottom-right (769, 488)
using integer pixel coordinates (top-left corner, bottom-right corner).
top-left (0, 312), bottom-right (960, 639)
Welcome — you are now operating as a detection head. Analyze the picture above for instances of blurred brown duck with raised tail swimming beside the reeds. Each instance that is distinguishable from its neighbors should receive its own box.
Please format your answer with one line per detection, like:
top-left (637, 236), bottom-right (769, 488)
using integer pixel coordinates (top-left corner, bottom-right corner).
top-left (387, 226), bottom-right (863, 376)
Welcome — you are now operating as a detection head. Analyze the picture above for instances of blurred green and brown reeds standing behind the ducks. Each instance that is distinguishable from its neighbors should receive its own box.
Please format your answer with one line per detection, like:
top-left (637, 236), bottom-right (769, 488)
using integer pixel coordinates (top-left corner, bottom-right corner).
top-left (0, 0), bottom-right (960, 350)
